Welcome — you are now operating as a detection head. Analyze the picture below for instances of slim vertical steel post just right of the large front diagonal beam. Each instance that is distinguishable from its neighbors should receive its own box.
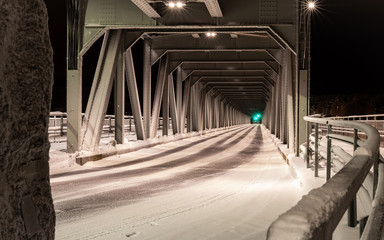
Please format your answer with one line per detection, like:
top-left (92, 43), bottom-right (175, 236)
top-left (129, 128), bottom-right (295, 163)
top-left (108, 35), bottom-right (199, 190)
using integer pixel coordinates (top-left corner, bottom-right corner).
top-left (115, 44), bottom-right (125, 144)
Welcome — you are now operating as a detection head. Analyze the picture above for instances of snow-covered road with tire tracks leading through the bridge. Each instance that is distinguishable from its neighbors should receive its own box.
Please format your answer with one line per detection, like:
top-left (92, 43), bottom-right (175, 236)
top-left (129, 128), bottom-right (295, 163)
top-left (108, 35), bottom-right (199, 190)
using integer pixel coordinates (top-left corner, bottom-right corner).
top-left (51, 125), bottom-right (303, 239)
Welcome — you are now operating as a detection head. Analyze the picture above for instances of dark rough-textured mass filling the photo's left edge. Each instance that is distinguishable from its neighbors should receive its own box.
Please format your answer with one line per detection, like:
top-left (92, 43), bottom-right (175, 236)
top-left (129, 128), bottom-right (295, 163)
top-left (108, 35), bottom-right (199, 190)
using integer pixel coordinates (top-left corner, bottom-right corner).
top-left (0, 0), bottom-right (55, 239)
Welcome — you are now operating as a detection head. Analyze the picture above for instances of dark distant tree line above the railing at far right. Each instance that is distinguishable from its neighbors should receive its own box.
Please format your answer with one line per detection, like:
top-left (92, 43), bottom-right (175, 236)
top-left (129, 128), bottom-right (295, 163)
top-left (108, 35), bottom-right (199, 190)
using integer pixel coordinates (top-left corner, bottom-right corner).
top-left (310, 94), bottom-right (384, 117)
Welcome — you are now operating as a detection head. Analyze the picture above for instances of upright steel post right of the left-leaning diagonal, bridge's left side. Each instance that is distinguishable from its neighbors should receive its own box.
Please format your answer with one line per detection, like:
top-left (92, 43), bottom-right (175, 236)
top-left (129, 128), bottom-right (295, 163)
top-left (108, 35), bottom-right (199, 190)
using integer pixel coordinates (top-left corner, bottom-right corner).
top-left (143, 38), bottom-right (152, 138)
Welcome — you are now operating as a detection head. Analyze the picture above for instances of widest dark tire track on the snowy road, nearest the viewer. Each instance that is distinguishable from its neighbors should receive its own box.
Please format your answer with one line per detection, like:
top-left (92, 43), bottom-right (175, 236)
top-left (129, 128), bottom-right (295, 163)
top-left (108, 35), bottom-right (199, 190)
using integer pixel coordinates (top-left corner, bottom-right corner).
top-left (56, 126), bottom-right (262, 223)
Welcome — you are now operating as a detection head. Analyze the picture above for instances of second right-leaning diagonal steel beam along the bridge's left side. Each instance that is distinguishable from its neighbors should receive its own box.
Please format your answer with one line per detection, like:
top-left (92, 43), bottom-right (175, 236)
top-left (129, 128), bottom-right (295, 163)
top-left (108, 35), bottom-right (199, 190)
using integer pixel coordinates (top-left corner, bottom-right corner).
top-left (151, 55), bottom-right (168, 138)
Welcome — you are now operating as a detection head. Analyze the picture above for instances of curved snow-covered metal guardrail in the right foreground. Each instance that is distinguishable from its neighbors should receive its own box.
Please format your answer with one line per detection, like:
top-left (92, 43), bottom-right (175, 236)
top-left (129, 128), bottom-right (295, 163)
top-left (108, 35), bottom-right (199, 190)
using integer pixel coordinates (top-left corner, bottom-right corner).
top-left (267, 117), bottom-right (384, 240)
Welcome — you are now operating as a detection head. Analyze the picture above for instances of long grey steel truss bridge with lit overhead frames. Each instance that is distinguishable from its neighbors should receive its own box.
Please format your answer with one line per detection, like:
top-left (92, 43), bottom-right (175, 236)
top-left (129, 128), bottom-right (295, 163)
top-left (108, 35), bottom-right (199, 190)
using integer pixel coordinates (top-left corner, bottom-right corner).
top-left (67, 0), bottom-right (384, 239)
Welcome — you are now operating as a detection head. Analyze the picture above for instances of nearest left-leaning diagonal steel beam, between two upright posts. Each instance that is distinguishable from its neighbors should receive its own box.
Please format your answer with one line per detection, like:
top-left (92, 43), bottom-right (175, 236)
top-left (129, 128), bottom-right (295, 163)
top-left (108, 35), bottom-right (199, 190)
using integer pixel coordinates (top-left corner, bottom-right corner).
top-left (125, 48), bottom-right (146, 140)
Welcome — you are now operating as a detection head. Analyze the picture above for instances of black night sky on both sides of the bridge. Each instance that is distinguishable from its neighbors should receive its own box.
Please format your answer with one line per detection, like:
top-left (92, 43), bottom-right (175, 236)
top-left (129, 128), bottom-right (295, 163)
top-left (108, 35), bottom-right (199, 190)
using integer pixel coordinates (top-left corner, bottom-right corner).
top-left (45, 0), bottom-right (384, 111)
